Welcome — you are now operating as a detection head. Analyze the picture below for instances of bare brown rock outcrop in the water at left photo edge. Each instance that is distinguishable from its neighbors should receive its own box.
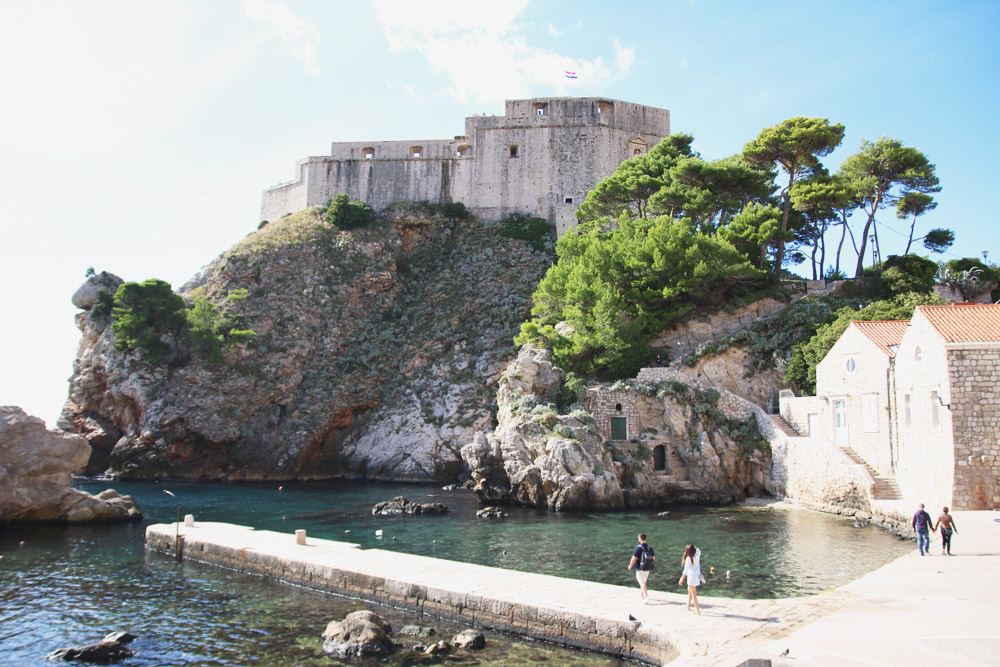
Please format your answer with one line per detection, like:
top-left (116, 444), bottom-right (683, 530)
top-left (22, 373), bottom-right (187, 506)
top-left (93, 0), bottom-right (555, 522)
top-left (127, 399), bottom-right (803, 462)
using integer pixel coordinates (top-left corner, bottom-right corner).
top-left (0, 406), bottom-right (142, 523)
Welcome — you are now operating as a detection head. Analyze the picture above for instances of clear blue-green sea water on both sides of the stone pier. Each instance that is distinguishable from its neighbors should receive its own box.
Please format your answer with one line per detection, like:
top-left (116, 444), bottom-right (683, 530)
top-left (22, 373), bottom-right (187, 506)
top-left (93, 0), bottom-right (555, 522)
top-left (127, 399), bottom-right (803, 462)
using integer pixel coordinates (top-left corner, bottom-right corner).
top-left (0, 480), bottom-right (910, 666)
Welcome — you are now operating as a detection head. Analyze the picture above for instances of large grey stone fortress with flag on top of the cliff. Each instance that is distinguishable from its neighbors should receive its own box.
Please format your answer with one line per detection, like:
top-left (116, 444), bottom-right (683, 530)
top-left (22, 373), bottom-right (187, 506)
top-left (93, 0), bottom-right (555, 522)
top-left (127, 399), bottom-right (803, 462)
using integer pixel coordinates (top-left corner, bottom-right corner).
top-left (261, 97), bottom-right (670, 235)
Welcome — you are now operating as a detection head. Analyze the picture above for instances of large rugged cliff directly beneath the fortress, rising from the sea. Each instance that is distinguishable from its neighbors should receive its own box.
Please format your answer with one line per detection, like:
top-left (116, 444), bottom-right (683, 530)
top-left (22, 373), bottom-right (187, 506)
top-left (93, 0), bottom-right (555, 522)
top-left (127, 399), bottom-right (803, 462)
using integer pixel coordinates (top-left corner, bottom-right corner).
top-left (59, 206), bottom-right (551, 482)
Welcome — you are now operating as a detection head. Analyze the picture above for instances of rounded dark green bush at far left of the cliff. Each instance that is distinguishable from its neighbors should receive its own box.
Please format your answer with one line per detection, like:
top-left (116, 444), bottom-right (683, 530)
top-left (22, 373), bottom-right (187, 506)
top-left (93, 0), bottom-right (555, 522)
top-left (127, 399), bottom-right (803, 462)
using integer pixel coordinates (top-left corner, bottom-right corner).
top-left (111, 278), bottom-right (186, 365)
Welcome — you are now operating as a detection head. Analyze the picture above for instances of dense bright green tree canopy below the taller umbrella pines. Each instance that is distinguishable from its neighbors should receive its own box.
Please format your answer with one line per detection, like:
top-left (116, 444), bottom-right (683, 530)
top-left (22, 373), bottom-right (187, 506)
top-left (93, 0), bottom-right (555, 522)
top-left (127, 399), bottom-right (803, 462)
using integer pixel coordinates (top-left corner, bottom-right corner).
top-left (517, 215), bottom-right (763, 379)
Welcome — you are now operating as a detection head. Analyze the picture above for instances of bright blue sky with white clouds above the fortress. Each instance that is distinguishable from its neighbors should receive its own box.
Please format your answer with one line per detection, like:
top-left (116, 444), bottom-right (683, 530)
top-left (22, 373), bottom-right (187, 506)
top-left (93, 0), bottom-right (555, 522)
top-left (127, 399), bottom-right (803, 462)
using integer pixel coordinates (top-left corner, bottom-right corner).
top-left (0, 0), bottom-right (1000, 428)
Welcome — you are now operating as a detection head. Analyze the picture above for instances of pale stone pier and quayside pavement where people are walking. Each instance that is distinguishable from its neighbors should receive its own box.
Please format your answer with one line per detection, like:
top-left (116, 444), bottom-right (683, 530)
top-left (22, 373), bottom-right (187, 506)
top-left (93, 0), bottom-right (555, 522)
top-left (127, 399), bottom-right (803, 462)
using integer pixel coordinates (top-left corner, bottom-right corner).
top-left (147, 512), bottom-right (1000, 667)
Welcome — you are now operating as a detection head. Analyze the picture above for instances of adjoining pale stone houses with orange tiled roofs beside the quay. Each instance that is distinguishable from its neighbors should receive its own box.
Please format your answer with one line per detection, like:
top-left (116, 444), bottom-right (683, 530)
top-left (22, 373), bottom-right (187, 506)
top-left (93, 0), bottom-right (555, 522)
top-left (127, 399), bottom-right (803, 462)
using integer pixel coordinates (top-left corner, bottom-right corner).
top-left (781, 304), bottom-right (1000, 509)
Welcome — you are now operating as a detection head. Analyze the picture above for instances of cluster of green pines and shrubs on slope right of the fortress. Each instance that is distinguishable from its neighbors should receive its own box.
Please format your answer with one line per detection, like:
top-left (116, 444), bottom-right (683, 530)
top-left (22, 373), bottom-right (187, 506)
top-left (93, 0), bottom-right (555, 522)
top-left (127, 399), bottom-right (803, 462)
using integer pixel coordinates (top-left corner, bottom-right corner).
top-left (517, 117), bottom-right (1000, 387)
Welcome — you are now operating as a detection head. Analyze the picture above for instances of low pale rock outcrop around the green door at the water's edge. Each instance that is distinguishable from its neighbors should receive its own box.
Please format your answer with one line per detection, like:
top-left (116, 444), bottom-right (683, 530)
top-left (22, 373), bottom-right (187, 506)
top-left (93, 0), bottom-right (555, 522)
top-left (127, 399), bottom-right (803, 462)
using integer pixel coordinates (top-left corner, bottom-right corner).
top-left (462, 345), bottom-right (773, 511)
